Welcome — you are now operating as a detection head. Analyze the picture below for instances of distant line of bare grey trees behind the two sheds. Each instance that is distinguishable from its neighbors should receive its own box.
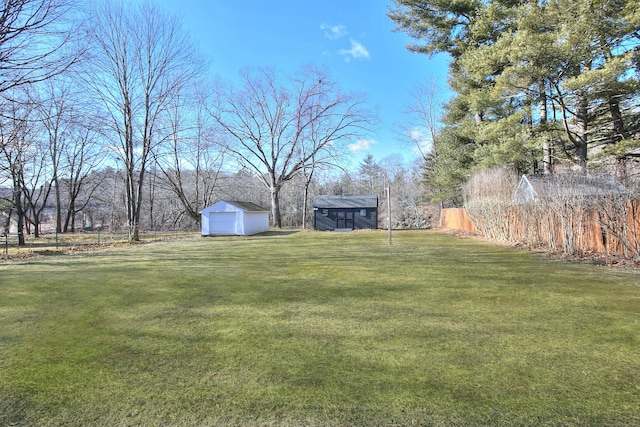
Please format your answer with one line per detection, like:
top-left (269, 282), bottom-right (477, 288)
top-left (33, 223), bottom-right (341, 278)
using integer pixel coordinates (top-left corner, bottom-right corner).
top-left (0, 152), bottom-right (430, 241)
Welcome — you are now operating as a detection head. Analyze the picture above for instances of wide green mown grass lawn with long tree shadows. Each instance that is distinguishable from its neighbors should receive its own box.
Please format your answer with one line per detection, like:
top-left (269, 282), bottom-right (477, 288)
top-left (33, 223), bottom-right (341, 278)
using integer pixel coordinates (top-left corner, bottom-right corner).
top-left (0, 231), bottom-right (640, 427)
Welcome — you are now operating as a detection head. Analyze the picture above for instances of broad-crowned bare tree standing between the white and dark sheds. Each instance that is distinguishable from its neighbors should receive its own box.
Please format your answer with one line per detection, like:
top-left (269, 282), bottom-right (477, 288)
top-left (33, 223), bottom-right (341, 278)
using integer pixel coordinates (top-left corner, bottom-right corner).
top-left (210, 67), bottom-right (372, 227)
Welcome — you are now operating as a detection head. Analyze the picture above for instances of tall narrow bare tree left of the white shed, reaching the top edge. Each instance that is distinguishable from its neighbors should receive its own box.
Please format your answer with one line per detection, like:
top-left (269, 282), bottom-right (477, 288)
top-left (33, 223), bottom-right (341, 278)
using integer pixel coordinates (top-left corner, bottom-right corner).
top-left (88, 1), bottom-right (202, 241)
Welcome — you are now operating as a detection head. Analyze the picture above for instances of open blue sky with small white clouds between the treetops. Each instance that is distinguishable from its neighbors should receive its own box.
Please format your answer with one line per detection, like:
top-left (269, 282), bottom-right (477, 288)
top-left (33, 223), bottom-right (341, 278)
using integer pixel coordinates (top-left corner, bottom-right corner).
top-left (155, 0), bottom-right (447, 171)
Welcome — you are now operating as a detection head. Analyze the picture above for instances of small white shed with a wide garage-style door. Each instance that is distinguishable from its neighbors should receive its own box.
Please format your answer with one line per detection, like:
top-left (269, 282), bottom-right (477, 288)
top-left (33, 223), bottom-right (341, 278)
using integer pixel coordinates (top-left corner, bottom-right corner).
top-left (200, 200), bottom-right (269, 236)
